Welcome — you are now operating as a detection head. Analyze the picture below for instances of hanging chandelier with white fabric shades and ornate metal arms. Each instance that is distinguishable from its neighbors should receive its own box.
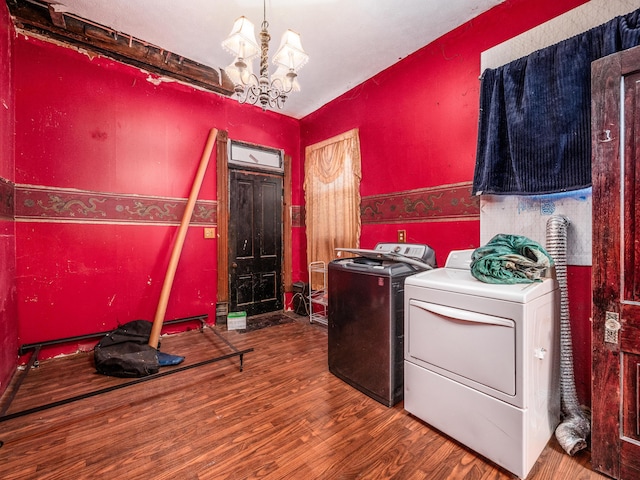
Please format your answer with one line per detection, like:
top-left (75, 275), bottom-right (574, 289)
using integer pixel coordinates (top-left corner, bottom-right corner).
top-left (222, 0), bottom-right (309, 110)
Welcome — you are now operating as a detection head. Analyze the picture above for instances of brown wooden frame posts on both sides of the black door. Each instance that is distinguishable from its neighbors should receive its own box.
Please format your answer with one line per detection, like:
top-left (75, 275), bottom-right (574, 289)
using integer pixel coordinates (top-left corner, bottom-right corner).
top-left (216, 130), bottom-right (293, 323)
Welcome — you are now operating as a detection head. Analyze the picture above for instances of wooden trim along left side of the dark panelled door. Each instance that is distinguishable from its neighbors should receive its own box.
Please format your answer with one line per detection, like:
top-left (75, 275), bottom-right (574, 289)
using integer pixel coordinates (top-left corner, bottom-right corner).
top-left (216, 130), bottom-right (229, 315)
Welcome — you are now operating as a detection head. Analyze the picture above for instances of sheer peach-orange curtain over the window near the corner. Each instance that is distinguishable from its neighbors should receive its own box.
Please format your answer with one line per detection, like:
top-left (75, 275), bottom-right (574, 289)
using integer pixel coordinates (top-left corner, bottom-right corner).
top-left (304, 129), bottom-right (362, 288)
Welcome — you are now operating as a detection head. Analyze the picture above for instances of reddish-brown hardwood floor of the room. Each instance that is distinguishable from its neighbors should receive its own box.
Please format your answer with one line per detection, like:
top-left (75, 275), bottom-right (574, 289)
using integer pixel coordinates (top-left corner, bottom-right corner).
top-left (0, 318), bottom-right (606, 480)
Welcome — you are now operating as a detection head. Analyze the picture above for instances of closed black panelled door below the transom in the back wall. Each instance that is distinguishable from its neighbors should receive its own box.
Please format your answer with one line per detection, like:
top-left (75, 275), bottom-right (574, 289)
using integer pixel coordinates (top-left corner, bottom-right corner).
top-left (229, 170), bottom-right (283, 316)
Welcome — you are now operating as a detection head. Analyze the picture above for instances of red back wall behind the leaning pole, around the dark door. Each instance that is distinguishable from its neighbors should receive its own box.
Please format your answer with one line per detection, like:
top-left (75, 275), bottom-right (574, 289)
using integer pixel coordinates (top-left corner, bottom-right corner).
top-left (14, 36), bottom-right (301, 356)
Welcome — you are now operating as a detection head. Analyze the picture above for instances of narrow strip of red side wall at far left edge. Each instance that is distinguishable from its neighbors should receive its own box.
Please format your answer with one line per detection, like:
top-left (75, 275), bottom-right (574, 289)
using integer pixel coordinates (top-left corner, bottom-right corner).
top-left (0, 2), bottom-right (18, 394)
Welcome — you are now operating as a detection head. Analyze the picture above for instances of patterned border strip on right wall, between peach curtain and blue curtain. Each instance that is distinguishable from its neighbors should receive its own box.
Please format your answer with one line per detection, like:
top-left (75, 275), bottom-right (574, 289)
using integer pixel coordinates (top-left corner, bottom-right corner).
top-left (360, 182), bottom-right (480, 225)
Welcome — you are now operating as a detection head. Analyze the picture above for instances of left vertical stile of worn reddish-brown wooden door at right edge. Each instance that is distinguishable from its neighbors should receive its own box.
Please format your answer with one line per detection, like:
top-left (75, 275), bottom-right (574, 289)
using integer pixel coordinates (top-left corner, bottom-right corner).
top-left (591, 43), bottom-right (621, 478)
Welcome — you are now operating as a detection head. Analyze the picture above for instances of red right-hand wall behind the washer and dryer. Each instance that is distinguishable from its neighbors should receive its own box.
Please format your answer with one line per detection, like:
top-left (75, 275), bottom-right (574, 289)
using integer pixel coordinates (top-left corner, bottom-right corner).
top-left (300, 0), bottom-right (591, 403)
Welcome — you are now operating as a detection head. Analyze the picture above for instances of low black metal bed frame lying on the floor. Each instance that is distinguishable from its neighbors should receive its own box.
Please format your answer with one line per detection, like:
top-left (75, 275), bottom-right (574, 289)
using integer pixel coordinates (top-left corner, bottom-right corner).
top-left (0, 315), bottom-right (253, 426)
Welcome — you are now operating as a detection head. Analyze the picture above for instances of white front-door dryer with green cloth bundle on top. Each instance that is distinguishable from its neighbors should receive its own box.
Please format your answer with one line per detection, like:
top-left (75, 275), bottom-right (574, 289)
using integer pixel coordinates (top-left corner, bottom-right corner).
top-left (404, 250), bottom-right (560, 478)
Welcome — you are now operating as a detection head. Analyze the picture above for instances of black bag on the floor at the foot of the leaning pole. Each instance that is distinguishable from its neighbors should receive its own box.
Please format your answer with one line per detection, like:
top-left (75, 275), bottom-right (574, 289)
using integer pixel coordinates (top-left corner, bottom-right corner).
top-left (93, 320), bottom-right (160, 377)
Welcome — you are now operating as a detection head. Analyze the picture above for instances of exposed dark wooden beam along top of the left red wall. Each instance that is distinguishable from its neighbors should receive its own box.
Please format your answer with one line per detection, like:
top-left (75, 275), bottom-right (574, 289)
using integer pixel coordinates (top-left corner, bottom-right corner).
top-left (7, 0), bottom-right (234, 96)
